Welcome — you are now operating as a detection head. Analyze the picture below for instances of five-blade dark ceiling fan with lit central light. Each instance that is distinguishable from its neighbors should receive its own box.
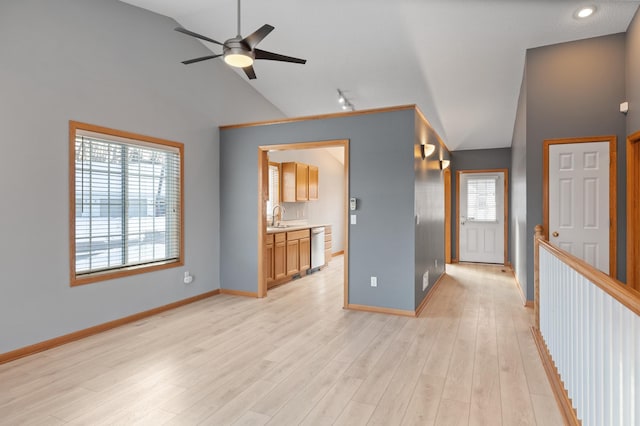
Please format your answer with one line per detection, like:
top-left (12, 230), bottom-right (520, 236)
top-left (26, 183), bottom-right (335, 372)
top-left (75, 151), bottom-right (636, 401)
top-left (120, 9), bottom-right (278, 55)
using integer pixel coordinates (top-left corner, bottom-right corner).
top-left (175, 0), bottom-right (307, 80)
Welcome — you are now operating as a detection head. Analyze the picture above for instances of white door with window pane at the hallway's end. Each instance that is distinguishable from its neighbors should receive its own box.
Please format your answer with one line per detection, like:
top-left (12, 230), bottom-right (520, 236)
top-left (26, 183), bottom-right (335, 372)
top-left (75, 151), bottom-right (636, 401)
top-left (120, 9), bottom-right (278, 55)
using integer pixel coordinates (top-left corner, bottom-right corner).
top-left (458, 172), bottom-right (505, 264)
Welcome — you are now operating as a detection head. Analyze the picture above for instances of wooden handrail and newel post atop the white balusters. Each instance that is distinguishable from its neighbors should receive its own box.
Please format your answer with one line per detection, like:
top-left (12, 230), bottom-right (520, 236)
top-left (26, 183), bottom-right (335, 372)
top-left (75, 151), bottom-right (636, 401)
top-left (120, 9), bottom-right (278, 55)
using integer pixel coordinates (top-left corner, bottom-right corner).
top-left (534, 230), bottom-right (640, 316)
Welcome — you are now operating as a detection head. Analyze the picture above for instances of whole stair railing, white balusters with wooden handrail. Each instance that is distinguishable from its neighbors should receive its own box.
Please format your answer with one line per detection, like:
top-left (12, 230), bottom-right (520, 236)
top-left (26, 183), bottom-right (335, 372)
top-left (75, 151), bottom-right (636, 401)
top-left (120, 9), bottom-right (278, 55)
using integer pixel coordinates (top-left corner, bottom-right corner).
top-left (534, 226), bottom-right (640, 426)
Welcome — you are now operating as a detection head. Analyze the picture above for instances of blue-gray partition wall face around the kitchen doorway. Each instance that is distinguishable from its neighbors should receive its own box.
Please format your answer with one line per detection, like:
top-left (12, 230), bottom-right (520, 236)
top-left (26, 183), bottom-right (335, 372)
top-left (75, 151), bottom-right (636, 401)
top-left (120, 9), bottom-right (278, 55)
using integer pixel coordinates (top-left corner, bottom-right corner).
top-left (220, 110), bottom-right (436, 310)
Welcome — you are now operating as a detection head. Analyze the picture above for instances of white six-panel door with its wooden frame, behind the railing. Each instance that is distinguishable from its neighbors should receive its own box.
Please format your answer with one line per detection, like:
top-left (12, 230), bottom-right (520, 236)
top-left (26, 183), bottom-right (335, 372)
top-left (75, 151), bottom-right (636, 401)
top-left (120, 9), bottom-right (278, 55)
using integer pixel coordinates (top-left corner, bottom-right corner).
top-left (542, 136), bottom-right (617, 277)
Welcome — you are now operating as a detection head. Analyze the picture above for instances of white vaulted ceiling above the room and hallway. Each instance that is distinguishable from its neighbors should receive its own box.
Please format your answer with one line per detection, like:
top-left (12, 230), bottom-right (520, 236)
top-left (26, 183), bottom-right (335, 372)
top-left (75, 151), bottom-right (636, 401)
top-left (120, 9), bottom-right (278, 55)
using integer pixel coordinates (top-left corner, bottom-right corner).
top-left (119, 0), bottom-right (640, 150)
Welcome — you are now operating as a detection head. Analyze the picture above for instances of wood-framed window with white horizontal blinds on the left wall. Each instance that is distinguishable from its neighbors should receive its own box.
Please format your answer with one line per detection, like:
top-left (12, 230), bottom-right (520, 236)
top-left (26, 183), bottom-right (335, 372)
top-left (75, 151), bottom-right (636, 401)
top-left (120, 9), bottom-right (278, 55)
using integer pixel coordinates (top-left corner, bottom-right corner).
top-left (69, 121), bottom-right (183, 285)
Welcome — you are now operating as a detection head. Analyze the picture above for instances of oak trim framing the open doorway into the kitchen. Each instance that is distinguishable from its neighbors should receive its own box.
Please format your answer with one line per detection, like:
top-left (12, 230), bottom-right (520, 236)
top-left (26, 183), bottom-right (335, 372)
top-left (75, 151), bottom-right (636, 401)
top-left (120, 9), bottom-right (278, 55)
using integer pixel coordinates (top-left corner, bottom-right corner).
top-left (257, 139), bottom-right (349, 307)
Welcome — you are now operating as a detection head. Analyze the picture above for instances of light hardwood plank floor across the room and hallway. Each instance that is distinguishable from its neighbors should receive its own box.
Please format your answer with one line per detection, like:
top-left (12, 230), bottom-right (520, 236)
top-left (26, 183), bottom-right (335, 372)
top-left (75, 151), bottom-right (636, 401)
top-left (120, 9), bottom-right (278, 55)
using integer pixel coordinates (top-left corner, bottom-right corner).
top-left (0, 257), bottom-right (562, 426)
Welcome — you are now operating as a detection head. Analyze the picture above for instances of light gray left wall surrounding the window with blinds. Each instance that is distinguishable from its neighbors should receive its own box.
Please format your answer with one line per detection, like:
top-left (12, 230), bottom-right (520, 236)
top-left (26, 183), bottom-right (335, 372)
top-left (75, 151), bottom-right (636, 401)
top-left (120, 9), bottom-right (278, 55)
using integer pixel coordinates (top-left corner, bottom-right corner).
top-left (0, 0), bottom-right (282, 353)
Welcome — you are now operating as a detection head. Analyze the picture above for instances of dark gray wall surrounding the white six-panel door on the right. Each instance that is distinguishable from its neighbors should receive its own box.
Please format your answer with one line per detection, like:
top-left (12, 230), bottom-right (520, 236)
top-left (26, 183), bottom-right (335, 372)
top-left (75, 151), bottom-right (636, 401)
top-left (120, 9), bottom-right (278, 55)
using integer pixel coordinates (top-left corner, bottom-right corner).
top-left (526, 34), bottom-right (626, 300)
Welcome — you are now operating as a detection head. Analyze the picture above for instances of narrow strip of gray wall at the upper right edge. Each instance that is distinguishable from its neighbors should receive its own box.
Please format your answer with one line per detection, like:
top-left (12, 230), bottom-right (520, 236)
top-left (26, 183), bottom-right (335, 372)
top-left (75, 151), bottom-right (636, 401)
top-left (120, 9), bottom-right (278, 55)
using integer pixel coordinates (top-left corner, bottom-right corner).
top-left (626, 9), bottom-right (640, 135)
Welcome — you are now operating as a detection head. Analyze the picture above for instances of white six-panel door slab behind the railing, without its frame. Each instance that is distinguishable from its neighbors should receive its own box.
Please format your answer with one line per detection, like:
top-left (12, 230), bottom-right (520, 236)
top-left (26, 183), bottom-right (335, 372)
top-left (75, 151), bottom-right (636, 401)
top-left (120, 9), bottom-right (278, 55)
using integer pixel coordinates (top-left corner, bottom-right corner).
top-left (549, 142), bottom-right (609, 274)
